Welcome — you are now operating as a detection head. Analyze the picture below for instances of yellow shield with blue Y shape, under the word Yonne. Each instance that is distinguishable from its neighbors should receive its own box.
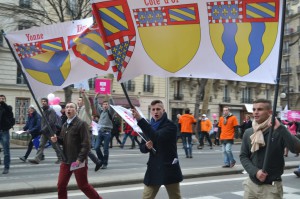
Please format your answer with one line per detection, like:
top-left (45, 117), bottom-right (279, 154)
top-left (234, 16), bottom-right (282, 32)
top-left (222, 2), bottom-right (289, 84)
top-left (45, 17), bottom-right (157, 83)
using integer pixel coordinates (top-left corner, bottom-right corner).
top-left (14, 38), bottom-right (71, 86)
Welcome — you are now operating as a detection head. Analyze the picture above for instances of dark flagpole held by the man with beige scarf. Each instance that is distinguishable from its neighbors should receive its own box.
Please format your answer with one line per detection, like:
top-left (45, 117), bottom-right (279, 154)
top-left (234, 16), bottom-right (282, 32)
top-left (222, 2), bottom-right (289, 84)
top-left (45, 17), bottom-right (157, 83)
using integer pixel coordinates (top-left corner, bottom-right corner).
top-left (262, 0), bottom-right (286, 172)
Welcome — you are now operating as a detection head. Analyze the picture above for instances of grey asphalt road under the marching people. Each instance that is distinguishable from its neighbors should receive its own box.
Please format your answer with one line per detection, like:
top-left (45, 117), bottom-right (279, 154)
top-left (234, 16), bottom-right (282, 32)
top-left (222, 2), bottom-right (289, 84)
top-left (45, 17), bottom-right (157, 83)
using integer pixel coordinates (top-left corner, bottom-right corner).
top-left (0, 144), bottom-right (300, 199)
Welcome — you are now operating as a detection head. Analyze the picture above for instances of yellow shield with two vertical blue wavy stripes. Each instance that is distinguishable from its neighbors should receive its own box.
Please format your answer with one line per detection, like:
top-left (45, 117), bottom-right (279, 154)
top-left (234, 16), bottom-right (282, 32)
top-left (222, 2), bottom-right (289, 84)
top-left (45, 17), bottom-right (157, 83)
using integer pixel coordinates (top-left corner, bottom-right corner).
top-left (207, 0), bottom-right (279, 76)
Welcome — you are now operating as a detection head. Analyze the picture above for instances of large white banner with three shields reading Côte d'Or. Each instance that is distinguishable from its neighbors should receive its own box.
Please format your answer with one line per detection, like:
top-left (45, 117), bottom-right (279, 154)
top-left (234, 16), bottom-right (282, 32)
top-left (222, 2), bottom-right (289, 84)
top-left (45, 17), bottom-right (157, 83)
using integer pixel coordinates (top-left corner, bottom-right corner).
top-left (92, 0), bottom-right (282, 84)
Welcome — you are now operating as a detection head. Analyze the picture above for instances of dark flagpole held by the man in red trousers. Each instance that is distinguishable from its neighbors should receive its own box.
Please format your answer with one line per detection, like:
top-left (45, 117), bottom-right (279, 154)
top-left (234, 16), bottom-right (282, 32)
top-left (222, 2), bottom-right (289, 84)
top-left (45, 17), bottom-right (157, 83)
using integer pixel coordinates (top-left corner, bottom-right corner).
top-left (1, 30), bottom-right (67, 161)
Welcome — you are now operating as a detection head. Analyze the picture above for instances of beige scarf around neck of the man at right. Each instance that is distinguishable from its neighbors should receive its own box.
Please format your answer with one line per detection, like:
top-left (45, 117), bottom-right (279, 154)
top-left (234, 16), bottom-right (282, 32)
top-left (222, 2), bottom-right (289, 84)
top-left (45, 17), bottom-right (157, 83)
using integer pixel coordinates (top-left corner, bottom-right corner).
top-left (250, 116), bottom-right (272, 153)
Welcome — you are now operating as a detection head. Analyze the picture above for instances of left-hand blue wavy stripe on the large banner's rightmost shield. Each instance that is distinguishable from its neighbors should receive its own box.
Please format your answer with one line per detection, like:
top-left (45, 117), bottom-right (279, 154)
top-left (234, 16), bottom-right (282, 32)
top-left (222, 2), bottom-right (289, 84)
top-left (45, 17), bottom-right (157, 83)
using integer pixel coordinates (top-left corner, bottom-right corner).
top-left (222, 23), bottom-right (237, 72)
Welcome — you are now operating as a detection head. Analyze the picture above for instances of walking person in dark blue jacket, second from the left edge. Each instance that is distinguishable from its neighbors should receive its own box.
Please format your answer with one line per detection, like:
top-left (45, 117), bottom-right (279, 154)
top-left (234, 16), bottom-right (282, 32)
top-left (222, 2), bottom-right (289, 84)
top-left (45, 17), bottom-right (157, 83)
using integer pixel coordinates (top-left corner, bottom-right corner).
top-left (20, 105), bottom-right (41, 162)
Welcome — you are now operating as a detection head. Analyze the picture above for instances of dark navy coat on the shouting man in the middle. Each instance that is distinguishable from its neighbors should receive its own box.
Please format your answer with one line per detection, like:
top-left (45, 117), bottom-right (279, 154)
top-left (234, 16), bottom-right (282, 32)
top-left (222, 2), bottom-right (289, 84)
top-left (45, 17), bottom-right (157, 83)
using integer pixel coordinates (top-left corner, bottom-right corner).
top-left (138, 113), bottom-right (183, 186)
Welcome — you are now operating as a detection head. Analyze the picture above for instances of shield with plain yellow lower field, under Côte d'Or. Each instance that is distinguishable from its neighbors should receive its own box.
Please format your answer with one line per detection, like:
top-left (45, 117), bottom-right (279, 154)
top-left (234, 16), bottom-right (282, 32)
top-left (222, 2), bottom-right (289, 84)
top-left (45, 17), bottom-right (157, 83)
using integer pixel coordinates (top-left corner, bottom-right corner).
top-left (133, 4), bottom-right (201, 72)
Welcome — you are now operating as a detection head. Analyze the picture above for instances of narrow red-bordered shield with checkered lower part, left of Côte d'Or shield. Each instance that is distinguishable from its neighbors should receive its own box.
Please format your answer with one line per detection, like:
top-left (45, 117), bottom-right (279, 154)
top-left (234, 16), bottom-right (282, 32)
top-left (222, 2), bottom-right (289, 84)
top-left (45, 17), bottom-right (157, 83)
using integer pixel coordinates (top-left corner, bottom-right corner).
top-left (92, 0), bottom-right (136, 80)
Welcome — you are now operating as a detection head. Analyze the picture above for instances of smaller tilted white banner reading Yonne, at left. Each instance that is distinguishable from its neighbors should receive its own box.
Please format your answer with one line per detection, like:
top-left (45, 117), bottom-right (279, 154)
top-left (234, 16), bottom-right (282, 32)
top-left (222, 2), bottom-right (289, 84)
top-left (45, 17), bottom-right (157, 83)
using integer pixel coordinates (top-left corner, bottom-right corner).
top-left (6, 18), bottom-right (113, 98)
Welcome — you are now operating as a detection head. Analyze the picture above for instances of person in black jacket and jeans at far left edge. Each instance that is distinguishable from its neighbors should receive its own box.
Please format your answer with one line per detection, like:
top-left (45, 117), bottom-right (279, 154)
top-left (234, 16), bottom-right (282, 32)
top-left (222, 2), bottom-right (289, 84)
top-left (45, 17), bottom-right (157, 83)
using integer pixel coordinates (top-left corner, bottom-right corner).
top-left (0, 95), bottom-right (15, 174)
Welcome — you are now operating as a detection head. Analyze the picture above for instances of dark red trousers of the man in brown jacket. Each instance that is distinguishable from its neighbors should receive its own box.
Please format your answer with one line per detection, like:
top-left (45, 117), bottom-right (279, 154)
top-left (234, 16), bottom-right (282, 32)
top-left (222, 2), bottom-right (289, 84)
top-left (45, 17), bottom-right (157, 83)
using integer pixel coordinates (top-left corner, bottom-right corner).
top-left (57, 163), bottom-right (102, 199)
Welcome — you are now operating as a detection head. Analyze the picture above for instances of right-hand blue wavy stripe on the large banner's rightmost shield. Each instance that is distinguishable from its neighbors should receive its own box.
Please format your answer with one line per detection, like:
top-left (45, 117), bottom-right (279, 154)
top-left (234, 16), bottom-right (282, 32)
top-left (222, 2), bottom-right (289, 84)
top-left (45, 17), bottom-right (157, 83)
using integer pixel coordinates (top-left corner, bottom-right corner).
top-left (248, 23), bottom-right (266, 72)
